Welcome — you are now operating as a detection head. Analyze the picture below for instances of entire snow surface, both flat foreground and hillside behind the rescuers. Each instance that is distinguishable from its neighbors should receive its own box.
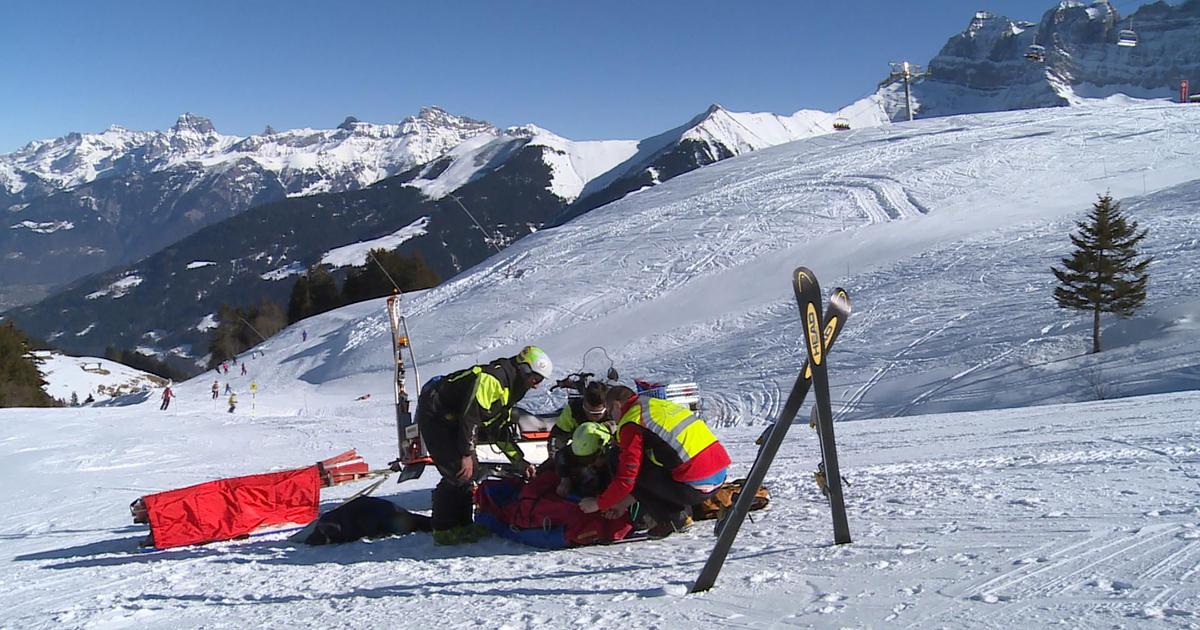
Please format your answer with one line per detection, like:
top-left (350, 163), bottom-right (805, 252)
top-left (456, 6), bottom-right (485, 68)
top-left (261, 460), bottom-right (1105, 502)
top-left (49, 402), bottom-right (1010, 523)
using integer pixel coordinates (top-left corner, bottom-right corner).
top-left (0, 103), bottom-right (1200, 629)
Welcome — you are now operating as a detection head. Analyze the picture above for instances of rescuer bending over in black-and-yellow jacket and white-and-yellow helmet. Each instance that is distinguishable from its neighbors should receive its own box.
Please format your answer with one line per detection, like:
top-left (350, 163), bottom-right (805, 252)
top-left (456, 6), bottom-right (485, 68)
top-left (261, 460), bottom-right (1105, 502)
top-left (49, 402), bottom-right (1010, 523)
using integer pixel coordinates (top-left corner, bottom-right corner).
top-left (416, 346), bottom-right (553, 545)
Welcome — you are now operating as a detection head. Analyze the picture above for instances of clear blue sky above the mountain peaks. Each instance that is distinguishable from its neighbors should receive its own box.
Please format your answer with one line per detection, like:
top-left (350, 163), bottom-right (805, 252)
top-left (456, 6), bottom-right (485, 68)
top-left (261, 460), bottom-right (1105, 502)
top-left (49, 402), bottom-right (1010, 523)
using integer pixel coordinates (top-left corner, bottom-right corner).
top-left (0, 0), bottom-right (1136, 152)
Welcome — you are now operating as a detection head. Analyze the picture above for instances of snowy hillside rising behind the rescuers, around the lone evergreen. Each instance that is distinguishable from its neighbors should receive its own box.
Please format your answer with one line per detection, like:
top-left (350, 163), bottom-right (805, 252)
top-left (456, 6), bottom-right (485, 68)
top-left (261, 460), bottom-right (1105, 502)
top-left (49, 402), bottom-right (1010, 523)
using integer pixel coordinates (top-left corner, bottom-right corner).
top-left (325, 99), bottom-right (1200, 422)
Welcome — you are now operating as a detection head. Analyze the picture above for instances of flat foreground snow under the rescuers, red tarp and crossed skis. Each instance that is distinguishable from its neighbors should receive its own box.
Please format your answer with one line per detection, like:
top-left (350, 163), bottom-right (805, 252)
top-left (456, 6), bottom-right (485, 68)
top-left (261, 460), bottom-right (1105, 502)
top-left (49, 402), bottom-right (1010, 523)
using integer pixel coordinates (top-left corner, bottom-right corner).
top-left (0, 345), bottom-right (1200, 629)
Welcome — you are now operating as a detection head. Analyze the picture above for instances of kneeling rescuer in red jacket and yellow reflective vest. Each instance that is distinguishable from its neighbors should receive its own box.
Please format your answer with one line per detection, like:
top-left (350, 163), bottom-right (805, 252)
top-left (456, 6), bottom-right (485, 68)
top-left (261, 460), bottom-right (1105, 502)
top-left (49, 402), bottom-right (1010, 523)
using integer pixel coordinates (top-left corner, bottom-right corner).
top-left (580, 385), bottom-right (730, 538)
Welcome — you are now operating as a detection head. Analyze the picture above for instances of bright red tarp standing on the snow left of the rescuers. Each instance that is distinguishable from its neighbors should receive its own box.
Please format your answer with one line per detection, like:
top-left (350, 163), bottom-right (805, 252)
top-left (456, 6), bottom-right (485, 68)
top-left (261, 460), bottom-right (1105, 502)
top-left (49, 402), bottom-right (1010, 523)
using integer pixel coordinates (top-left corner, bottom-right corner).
top-left (142, 466), bottom-right (320, 548)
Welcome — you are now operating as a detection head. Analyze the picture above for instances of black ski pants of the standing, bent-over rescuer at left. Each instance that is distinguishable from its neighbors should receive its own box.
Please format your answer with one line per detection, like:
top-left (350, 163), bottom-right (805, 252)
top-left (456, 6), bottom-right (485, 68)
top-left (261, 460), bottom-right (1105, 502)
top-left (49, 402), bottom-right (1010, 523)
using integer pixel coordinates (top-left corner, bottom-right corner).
top-left (416, 388), bottom-right (480, 530)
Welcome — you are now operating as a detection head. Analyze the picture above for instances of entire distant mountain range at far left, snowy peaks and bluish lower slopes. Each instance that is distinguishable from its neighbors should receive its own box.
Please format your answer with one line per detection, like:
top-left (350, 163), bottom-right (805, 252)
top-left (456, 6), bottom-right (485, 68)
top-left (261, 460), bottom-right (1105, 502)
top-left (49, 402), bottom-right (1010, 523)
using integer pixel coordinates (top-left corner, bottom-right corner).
top-left (0, 108), bottom-right (493, 308)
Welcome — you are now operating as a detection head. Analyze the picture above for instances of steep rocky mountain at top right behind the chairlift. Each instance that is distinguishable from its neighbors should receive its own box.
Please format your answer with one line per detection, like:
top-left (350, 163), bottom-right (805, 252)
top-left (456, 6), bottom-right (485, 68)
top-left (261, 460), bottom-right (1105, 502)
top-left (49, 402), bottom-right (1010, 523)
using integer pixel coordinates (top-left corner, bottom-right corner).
top-left (877, 0), bottom-right (1200, 120)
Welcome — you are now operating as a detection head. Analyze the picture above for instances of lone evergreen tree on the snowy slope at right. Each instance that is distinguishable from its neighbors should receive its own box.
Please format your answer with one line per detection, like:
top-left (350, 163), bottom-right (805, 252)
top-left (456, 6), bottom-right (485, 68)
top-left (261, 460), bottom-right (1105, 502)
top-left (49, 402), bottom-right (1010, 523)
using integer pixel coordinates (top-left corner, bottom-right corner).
top-left (1050, 193), bottom-right (1152, 353)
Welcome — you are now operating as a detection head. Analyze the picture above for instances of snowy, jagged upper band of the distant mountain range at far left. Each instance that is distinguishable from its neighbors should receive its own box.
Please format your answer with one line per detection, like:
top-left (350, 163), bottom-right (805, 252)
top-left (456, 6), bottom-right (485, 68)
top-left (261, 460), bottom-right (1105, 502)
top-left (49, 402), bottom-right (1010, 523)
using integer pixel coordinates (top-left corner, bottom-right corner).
top-left (0, 107), bottom-right (493, 199)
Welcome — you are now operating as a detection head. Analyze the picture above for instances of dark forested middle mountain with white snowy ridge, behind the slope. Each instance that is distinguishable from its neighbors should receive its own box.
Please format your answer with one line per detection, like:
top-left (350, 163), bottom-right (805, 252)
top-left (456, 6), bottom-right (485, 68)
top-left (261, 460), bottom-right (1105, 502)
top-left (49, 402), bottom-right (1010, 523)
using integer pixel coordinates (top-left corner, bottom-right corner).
top-left (10, 106), bottom-right (886, 356)
